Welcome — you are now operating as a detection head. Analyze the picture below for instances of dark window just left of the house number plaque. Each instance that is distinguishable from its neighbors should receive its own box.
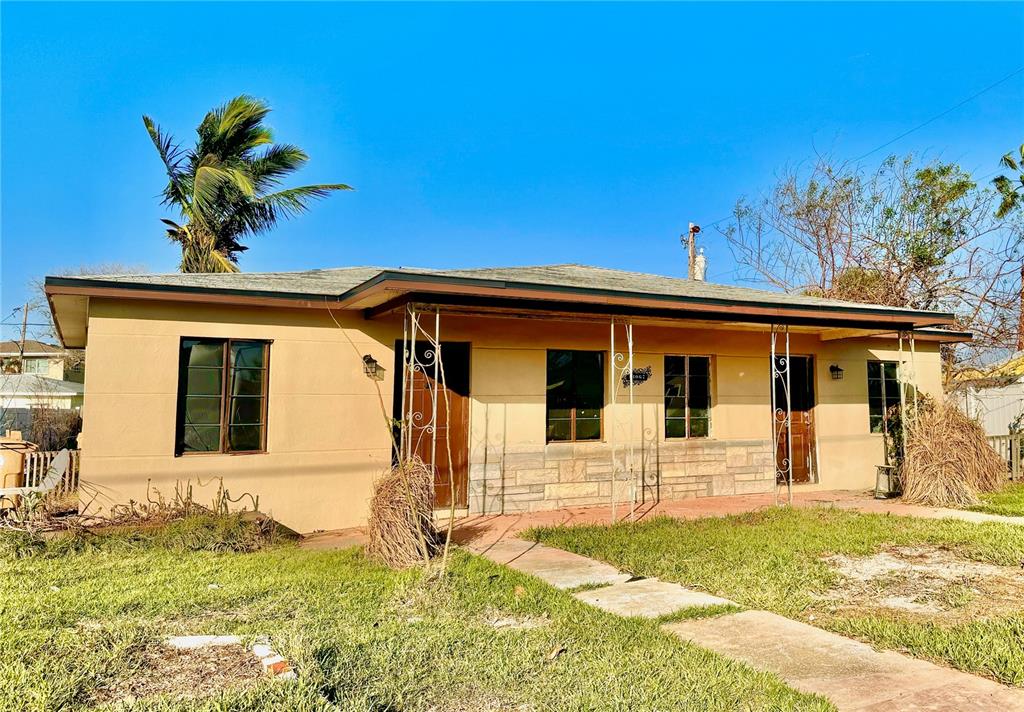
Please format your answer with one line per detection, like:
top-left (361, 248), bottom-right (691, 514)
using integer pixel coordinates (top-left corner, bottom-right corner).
top-left (547, 349), bottom-right (604, 443)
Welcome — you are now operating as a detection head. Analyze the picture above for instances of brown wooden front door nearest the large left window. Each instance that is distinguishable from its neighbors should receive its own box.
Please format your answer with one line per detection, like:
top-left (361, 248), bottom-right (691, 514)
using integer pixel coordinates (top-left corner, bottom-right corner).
top-left (395, 341), bottom-right (469, 507)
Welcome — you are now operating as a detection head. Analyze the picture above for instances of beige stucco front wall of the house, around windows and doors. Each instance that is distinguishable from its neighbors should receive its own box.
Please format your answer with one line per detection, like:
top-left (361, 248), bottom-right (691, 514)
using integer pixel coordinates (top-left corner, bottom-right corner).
top-left (81, 299), bottom-right (941, 531)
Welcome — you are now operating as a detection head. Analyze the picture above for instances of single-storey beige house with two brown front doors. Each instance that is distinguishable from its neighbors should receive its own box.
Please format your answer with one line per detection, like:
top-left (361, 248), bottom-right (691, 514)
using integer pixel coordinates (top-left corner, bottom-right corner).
top-left (46, 264), bottom-right (970, 531)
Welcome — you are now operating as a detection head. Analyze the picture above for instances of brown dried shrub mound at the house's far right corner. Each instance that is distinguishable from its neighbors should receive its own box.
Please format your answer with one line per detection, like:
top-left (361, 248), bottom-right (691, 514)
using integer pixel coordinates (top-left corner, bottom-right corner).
top-left (901, 402), bottom-right (1007, 507)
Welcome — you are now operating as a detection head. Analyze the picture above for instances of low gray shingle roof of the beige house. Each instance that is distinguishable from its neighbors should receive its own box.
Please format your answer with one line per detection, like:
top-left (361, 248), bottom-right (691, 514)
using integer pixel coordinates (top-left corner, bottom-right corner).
top-left (59, 264), bottom-right (950, 311)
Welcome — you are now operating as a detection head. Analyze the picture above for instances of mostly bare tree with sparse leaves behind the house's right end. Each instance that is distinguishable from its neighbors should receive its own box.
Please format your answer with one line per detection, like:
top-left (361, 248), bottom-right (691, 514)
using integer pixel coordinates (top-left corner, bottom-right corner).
top-left (720, 156), bottom-right (1024, 376)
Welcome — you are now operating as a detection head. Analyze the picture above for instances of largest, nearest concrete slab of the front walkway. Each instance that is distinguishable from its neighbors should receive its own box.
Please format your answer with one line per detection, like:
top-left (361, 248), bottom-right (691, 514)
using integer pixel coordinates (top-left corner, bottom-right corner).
top-left (665, 611), bottom-right (1024, 712)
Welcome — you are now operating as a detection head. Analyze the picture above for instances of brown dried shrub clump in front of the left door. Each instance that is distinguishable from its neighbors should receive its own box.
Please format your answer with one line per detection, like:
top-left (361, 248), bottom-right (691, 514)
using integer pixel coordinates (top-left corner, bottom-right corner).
top-left (366, 460), bottom-right (441, 569)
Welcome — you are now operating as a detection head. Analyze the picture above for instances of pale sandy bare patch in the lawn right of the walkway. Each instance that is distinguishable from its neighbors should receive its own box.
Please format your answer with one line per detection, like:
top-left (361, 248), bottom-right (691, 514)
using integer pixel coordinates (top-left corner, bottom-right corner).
top-left (822, 546), bottom-right (1024, 621)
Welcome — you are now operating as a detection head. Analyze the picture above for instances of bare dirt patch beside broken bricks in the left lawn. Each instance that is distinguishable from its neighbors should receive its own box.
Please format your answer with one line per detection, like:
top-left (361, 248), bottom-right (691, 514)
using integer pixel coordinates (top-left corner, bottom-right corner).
top-left (93, 643), bottom-right (266, 704)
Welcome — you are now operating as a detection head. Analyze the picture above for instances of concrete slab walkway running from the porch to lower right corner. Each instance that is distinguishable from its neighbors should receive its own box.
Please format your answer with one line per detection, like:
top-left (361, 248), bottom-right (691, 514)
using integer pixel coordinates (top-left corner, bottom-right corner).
top-left (470, 538), bottom-right (1024, 712)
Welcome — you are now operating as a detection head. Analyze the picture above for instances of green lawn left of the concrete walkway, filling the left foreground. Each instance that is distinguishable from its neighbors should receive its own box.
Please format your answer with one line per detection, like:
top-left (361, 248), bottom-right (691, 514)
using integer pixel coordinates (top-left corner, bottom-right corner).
top-left (0, 524), bottom-right (830, 712)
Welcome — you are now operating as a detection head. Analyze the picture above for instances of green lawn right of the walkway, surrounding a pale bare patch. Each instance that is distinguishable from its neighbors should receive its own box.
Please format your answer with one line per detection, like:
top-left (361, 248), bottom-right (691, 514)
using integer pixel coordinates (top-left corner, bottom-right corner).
top-left (524, 508), bottom-right (1024, 685)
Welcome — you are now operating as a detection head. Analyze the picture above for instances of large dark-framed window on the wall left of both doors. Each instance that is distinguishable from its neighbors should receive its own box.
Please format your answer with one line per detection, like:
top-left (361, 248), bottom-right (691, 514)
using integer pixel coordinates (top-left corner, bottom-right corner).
top-left (174, 337), bottom-right (270, 455)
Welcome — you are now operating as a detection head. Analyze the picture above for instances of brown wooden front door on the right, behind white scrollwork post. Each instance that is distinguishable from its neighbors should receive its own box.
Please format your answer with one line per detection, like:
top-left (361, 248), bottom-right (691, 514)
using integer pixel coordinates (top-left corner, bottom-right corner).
top-left (772, 355), bottom-right (815, 483)
